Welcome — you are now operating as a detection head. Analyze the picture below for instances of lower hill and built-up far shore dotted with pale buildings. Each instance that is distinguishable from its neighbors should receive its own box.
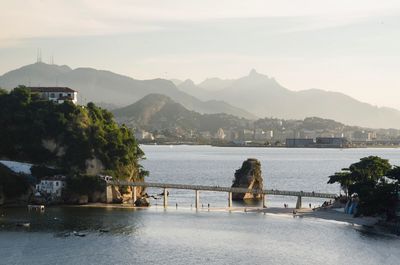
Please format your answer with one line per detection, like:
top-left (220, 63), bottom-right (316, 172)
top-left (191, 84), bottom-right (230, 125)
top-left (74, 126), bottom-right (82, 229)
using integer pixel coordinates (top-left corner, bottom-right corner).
top-left (112, 94), bottom-right (400, 145)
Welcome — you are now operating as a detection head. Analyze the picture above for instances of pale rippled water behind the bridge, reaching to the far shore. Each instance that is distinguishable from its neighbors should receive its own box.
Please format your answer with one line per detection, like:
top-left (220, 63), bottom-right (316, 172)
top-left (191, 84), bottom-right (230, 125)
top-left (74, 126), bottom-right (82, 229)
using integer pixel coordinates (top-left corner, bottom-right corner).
top-left (142, 146), bottom-right (400, 207)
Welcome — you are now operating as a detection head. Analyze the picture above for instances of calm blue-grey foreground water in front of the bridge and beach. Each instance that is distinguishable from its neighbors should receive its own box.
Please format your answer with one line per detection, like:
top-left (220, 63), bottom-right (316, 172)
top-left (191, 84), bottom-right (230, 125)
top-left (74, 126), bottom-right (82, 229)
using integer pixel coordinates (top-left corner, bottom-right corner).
top-left (0, 207), bottom-right (400, 265)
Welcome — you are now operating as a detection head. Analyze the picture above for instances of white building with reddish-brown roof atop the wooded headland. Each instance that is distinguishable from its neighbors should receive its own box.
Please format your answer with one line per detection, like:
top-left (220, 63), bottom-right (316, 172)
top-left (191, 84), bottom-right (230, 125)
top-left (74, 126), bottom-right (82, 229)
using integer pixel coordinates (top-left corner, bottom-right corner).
top-left (28, 87), bottom-right (78, 104)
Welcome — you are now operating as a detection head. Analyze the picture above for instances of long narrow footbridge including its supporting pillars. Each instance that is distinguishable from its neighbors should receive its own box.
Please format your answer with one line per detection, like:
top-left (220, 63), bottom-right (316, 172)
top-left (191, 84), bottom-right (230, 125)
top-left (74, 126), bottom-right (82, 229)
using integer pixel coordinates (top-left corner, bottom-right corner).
top-left (108, 181), bottom-right (337, 209)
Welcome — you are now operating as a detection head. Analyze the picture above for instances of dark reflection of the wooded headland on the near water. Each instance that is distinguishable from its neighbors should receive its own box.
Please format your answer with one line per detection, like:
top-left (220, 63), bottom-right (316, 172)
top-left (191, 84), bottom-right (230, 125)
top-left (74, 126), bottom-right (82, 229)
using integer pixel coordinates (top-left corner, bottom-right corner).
top-left (0, 207), bottom-right (142, 237)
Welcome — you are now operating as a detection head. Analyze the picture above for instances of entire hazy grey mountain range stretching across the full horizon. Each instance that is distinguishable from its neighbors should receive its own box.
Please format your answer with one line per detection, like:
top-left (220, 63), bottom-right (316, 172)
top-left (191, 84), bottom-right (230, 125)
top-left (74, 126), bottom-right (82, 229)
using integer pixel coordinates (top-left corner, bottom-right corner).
top-left (0, 63), bottom-right (400, 128)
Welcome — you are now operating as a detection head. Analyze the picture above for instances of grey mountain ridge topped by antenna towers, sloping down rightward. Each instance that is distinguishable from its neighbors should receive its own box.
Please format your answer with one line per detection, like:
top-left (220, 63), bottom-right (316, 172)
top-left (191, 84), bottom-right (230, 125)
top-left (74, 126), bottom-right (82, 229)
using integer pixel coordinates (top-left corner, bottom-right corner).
top-left (0, 63), bottom-right (256, 119)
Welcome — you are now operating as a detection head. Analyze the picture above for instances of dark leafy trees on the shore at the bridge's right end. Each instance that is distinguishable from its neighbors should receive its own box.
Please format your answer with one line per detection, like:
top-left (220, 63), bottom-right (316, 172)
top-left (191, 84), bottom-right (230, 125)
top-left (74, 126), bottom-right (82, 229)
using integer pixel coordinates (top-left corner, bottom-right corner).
top-left (328, 156), bottom-right (400, 219)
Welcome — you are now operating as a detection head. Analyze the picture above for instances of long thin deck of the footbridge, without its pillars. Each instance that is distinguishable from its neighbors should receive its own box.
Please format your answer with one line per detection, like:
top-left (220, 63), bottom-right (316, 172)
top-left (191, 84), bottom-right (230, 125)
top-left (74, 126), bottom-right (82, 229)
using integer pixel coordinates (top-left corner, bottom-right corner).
top-left (108, 181), bottom-right (337, 199)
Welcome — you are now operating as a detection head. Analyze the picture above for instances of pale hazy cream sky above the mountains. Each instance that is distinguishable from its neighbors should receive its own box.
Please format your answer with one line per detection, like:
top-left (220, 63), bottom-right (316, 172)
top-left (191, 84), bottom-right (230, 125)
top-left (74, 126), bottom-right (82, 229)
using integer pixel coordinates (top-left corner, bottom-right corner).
top-left (0, 0), bottom-right (400, 109)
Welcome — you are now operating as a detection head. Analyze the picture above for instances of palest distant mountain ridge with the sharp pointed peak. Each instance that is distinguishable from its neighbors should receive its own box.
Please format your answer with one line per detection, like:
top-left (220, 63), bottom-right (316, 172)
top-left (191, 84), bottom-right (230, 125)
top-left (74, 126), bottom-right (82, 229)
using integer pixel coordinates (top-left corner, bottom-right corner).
top-left (178, 70), bottom-right (400, 128)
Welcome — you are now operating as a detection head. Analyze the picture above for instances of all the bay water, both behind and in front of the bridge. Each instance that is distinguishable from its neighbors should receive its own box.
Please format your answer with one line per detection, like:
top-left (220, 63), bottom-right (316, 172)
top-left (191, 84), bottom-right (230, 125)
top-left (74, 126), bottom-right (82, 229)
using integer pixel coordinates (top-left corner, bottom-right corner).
top-left (0, 146), bottom-right (400, 265)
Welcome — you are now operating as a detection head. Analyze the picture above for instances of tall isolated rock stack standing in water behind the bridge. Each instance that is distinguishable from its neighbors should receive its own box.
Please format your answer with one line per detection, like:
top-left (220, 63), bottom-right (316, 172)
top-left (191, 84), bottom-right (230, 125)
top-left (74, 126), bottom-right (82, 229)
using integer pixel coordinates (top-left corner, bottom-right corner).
top-left (232, 158), bottom-right (264, 200)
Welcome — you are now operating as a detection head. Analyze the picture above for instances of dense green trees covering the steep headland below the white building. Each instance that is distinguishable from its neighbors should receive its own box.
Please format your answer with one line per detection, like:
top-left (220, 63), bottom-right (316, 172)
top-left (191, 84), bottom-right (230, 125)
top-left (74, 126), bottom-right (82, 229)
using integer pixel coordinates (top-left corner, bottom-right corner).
top-left (0, 86), bottom-right (147, 178)
